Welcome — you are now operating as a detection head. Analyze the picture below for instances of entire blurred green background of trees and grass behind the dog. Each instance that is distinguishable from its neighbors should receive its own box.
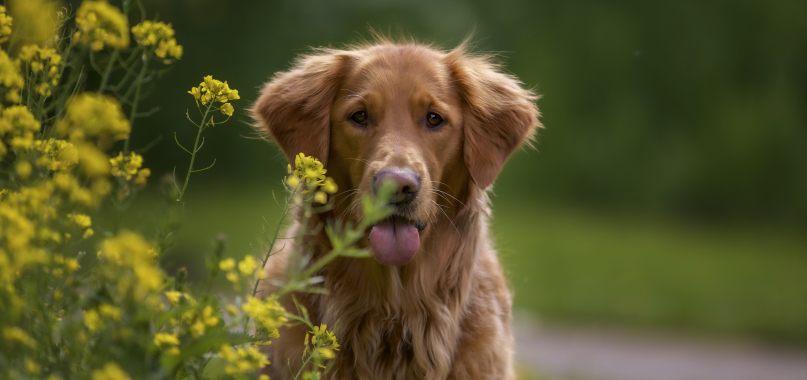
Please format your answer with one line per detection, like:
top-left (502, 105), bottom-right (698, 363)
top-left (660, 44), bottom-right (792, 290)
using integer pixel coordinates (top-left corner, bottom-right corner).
top-left (101, 0), bottom-right (807, 345)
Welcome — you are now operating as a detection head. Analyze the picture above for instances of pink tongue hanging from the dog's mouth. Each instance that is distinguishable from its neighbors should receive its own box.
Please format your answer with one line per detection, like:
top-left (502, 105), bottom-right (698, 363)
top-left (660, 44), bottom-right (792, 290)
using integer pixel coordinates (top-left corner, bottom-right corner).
top-left (370, 221), bottom-right (420, 266)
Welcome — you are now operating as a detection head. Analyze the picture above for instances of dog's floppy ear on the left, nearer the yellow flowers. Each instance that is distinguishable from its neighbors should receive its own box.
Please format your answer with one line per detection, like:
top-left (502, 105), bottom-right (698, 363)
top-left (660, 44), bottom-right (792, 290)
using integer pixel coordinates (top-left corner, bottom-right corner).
top-left (251, 49), bottom-right (349, 165)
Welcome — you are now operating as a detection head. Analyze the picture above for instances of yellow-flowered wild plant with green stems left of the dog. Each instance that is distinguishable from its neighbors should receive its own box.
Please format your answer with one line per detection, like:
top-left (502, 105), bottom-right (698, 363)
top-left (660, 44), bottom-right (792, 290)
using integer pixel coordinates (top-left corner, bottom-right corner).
top-left (0, 0), bottom-right (398, 380)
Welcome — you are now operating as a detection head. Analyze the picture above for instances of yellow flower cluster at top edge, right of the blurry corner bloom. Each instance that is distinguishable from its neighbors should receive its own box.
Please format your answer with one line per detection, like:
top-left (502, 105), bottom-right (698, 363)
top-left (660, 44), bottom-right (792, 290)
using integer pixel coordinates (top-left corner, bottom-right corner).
top-left (73, 0), bottom-right (129, 51)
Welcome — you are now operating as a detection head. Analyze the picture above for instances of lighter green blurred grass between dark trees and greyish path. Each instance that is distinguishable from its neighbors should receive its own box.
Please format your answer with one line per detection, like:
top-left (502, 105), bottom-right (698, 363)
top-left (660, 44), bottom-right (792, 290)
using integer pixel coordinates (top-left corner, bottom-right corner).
top-left (130, 184), bottom-right (807, 345)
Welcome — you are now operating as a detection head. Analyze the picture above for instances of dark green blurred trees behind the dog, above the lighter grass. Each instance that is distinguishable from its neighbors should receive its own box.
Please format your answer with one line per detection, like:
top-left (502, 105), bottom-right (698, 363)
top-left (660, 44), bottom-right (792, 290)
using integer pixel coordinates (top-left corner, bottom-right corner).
top-left (73, 0), bottom-right (807, 228)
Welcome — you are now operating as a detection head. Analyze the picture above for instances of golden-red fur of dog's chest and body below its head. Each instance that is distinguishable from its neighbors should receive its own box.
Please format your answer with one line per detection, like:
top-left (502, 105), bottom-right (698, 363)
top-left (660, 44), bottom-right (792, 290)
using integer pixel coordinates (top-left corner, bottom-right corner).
top-left (269, 200), bottom-right (513, 379)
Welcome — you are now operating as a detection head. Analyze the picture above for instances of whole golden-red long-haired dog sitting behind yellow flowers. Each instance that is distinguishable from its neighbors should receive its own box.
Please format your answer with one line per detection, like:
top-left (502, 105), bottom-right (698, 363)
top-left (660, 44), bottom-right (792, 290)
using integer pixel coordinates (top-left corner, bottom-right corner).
top-left (252, 38), bottom-right (541, 379)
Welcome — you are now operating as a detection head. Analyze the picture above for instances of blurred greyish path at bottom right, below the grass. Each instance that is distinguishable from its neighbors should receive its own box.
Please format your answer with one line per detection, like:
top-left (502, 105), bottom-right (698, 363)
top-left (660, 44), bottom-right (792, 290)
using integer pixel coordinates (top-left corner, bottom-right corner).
top-left (513, 319), bottom-right (807, 380)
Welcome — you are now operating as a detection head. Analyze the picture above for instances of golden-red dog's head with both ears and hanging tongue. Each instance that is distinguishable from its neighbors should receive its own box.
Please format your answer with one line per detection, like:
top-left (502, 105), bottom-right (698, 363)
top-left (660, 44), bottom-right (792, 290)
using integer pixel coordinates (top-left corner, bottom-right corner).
top-left (252, 41), bottom-right (541, 266)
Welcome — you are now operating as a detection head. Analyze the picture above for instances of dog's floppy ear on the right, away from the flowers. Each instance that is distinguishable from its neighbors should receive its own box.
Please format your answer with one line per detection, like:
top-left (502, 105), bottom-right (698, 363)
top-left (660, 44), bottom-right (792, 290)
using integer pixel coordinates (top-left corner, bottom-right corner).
top-left (446, 48), bottom-right (543, 189)
